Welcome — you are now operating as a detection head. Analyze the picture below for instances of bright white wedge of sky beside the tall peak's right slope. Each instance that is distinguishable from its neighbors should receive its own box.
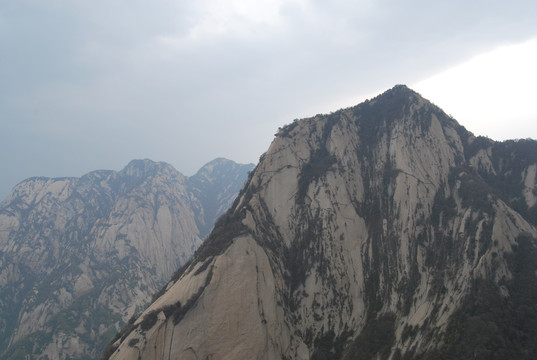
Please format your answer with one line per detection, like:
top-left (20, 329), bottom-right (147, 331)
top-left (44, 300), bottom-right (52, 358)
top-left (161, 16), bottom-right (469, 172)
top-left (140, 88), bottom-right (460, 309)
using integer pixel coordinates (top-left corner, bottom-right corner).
top-left (412, 38), bottom-right (537, 140)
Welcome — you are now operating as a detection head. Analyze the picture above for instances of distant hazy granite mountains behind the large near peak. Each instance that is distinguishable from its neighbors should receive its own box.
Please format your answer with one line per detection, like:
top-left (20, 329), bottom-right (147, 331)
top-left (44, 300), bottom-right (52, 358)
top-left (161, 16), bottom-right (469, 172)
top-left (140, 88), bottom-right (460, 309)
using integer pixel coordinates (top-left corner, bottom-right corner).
top-left (0, 159), bottom-right (253, 359)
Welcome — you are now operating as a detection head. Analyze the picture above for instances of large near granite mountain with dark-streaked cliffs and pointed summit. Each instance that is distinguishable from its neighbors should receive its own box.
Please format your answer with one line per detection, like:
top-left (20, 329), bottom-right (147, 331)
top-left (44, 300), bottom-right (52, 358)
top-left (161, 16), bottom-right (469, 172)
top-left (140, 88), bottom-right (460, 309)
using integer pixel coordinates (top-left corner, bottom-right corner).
top-left (103, 86), bottom-right (537, 360)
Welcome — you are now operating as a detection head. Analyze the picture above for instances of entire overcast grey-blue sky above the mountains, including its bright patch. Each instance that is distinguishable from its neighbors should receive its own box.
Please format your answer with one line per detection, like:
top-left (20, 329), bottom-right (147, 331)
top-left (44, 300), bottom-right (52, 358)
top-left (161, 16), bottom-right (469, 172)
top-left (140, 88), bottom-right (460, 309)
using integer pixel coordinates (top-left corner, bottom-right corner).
top-left (0, 0), bottom-right (537, 199)
